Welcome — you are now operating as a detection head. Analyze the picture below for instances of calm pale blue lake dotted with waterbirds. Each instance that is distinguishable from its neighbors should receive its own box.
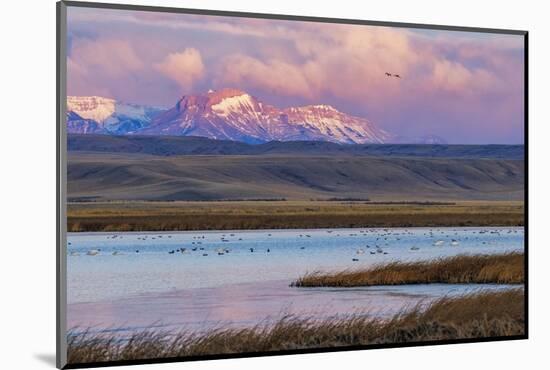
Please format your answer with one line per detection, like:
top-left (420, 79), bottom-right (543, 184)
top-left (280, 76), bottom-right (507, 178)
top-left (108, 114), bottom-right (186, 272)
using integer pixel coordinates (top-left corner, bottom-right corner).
top-left (67, 228), bottom-right (524, 330)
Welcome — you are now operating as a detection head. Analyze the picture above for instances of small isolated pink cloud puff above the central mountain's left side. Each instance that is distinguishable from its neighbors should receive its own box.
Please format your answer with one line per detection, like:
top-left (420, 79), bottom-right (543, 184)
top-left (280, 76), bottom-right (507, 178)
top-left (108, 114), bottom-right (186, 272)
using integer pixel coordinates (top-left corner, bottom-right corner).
top-left (155, 48), bottom-right (205, 90)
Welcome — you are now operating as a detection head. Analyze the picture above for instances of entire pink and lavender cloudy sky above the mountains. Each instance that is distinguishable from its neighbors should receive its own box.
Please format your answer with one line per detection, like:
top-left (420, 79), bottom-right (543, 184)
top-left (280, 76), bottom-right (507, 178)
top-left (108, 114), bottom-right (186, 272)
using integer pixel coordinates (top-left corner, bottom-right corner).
top-left (67, 7), bottom-right (525, 144)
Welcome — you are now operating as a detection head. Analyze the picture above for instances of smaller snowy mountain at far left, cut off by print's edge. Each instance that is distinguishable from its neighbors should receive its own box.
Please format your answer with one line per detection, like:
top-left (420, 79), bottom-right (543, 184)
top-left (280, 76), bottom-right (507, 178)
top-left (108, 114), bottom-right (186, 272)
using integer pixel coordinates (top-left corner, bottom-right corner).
top-left (67, 96), bottom-right (163, 135)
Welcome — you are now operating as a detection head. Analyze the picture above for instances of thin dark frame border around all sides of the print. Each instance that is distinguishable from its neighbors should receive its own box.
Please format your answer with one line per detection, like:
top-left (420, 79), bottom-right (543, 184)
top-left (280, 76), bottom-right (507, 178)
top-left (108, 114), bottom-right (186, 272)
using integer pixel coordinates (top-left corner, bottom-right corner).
top-left (56, 1), bottom-right (529, 369)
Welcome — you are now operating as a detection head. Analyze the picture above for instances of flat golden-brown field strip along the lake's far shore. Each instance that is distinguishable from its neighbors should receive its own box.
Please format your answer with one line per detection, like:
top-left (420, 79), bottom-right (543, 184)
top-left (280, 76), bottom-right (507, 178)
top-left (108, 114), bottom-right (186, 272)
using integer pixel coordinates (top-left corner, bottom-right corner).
top-left (68, 201), bottom-right (524, 232)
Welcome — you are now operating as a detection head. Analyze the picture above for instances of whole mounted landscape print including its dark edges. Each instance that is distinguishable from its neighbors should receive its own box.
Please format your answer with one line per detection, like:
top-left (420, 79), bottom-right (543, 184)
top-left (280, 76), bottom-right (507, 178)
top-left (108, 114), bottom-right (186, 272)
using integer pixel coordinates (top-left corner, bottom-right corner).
top-left (57, 2), bottom-right (527, 368)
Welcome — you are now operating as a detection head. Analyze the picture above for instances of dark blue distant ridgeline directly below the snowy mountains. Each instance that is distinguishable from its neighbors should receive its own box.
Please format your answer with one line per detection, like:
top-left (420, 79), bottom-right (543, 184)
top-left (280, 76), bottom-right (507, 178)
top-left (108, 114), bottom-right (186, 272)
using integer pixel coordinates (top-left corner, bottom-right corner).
top-left (67, 134), bottom-right (525, 160)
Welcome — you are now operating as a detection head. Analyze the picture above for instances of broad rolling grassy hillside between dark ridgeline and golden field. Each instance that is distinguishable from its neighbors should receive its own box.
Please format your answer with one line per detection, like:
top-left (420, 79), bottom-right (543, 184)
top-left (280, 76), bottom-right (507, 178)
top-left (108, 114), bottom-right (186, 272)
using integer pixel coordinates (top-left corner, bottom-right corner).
top-left (68, 152), bottom-right (524, 201)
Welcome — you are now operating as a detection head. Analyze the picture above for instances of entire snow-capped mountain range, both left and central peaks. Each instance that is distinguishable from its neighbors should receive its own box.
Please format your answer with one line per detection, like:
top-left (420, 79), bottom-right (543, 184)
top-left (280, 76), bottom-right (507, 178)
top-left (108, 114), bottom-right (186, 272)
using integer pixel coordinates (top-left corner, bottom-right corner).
top-left (67, 89), bottom-right (392, 144)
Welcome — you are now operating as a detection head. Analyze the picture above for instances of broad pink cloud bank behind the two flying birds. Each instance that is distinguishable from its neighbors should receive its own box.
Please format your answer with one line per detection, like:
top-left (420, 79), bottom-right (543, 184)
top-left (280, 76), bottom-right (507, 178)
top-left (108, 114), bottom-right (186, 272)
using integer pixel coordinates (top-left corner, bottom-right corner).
top-left (216, 24), bottom-right (518, 110)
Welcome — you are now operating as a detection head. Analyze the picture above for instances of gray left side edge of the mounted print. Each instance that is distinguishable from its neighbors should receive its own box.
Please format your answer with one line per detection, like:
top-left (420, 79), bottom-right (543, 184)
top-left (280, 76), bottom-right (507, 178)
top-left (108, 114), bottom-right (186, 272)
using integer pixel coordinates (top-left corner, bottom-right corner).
top-left (55, 2), bottom-right (67, 369)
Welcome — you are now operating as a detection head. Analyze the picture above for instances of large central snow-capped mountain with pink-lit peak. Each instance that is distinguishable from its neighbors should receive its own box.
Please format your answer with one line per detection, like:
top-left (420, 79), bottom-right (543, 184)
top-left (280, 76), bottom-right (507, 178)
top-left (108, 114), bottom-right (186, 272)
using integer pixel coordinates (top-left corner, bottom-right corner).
top-left (140, 89), bottom-right (390, 143)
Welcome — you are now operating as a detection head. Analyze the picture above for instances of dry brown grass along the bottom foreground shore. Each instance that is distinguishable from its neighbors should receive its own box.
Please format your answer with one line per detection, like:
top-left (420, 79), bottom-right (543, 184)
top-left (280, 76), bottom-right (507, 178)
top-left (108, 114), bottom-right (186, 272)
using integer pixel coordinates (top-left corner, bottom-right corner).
top-left (68, 289), bottom-right (525, 364)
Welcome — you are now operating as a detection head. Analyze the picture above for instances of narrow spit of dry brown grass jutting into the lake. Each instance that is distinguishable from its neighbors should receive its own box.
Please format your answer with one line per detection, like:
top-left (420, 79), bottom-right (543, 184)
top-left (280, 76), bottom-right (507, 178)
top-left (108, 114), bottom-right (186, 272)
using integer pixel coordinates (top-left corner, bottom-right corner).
top-left (291, 252), bottom-right (524, 287)
